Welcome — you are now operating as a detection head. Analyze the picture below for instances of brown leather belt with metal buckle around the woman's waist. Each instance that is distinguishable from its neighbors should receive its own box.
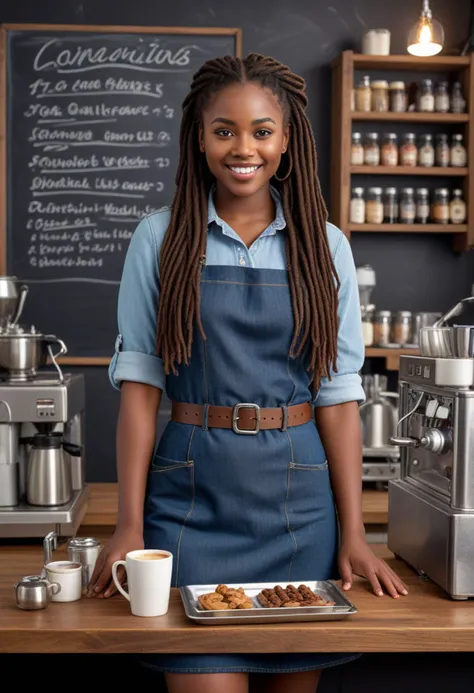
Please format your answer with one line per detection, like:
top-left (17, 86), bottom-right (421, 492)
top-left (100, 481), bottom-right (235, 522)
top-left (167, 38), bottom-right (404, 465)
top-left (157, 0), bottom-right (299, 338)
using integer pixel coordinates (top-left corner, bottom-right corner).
top-left (171, 402), bottom-right (313, 435)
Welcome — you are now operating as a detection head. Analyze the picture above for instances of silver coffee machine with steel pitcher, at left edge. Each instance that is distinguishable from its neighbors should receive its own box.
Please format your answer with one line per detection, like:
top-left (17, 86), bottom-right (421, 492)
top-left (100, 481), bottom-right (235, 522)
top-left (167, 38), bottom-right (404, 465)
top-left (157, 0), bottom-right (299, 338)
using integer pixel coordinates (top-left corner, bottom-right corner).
top-left (0, 277), bottom-right (88, 538)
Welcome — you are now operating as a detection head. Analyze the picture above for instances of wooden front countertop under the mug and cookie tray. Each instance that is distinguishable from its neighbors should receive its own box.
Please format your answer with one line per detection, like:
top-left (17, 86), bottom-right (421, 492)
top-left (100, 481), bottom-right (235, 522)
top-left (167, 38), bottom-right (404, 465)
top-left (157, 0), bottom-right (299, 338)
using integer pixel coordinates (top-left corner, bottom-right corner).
top-left (0, 542), bottom-right (474, 653)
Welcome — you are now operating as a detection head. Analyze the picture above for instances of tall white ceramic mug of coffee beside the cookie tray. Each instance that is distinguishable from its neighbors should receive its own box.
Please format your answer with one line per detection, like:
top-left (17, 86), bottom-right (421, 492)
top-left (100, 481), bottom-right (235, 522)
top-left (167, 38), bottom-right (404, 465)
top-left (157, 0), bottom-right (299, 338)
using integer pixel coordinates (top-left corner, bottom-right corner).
top-left (112, 549), bottom-right (173, 616)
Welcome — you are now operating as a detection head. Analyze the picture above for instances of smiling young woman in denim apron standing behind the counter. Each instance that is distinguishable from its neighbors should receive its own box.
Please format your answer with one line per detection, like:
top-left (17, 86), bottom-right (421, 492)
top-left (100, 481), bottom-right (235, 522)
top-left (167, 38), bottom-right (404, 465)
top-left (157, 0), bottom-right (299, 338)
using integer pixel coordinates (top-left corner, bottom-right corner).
top-left (90, 54), bottom-right (406, 693)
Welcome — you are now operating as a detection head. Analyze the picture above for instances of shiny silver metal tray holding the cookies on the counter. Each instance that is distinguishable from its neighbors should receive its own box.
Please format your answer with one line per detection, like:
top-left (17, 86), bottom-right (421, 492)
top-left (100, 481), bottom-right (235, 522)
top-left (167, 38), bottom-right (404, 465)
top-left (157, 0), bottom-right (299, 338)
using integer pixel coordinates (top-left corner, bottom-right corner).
top-left (179, 580), bottom-right (357, 626)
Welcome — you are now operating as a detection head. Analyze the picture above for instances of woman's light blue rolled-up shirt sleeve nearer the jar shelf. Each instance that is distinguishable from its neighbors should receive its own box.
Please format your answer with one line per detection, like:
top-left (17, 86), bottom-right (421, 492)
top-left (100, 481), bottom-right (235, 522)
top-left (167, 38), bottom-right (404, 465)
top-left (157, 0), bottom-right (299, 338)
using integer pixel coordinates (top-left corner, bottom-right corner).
top-left (314, 231), bottom-right (365, 407)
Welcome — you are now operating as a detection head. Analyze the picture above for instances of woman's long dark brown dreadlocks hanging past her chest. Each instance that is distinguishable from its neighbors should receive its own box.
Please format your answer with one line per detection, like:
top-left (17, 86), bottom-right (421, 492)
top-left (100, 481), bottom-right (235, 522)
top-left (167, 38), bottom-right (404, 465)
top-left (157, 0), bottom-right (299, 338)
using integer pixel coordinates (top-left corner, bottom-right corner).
top-left (157, 53), bottom-right (339, 389)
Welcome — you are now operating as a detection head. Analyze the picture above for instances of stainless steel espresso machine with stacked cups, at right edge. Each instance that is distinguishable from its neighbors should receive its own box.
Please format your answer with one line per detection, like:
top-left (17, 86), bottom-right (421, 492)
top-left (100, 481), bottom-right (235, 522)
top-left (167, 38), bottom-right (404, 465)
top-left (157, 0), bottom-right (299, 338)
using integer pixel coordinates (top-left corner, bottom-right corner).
top-left (388, 297), bottom-right (474, 599)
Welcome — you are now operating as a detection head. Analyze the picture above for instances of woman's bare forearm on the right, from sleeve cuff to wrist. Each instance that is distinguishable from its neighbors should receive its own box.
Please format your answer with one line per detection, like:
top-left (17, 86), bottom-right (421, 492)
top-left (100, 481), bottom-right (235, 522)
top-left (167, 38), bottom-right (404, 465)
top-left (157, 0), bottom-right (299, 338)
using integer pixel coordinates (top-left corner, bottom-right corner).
top-left (315, 402), bottom-right (364, 537)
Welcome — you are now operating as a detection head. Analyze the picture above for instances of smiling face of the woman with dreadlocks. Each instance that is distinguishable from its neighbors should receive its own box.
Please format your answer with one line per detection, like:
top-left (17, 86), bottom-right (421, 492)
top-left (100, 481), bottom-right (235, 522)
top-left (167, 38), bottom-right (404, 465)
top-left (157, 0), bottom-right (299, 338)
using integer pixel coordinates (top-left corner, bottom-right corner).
top-left (199, 82), bottom-right (289, 197)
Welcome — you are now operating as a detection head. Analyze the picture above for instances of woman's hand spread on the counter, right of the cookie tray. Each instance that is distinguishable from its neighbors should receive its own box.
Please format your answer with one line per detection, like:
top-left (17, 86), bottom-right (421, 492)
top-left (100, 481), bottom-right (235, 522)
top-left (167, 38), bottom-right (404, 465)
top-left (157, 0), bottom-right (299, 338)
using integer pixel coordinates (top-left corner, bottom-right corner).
top-left (338, 536), bottom-right (408, 599)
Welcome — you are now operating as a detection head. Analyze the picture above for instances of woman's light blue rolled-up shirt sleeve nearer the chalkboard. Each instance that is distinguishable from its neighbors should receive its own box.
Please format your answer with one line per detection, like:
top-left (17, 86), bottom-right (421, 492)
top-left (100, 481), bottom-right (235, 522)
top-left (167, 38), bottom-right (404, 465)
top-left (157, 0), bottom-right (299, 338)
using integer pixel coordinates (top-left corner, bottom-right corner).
top-left (109, 217), bottom-right (166, 390)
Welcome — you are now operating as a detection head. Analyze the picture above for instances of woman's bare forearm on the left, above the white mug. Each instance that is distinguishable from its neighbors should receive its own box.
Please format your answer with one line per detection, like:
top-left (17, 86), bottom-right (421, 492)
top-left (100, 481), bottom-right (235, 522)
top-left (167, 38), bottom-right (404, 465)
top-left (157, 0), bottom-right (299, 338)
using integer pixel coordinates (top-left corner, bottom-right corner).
top-left (116, 382), bottom-right (161, 531)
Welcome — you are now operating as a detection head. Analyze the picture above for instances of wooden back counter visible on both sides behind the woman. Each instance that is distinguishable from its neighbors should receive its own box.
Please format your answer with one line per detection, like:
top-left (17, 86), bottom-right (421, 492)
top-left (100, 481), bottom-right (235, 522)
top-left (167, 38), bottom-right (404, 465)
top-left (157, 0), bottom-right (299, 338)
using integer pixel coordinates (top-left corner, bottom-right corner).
top-left (81, 483), bottom-right (388, 528)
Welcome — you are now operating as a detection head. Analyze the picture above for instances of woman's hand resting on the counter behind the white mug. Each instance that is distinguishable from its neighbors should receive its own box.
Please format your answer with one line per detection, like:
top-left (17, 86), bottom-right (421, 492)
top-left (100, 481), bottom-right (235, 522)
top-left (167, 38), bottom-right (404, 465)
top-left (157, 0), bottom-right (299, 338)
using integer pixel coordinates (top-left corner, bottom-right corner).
top-left (87, 529), bottom-right (144, 597)
